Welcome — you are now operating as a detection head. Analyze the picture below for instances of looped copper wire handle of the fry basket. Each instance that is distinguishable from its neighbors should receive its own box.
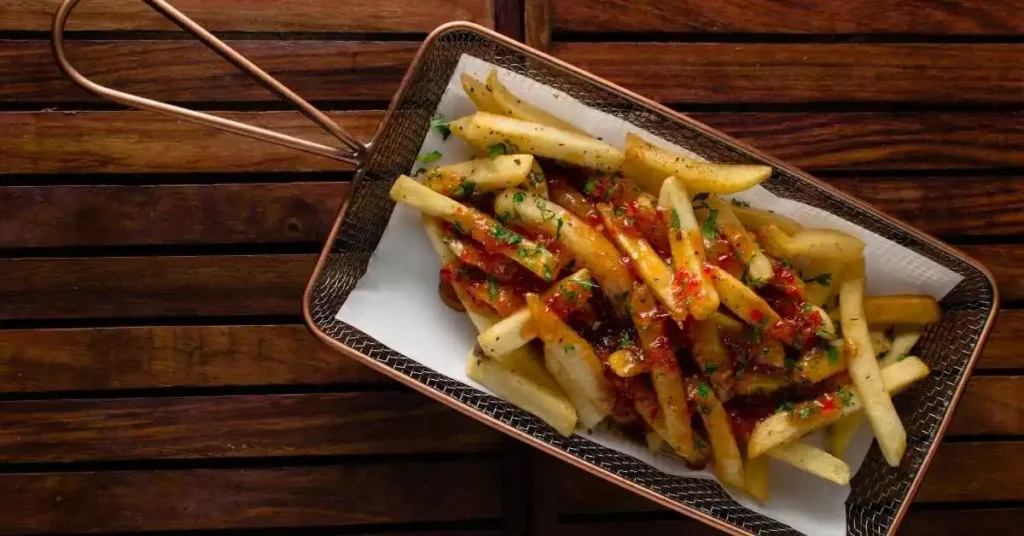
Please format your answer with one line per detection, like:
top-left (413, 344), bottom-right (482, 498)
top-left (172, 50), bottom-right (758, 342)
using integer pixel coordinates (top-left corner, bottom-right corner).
top-left (51, 0), bottom-right (369, 165)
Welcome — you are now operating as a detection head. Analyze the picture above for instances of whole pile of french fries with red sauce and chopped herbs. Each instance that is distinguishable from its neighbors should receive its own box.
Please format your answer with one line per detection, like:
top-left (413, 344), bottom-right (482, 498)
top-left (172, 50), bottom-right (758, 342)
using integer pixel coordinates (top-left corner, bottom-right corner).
top-left (391, 72), bottom-right (940, 500)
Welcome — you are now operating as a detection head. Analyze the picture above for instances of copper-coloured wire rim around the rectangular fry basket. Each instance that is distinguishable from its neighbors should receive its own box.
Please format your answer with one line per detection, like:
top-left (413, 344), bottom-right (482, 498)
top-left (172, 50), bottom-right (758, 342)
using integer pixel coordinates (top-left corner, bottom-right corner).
top-left (302, 22), bottom-right (999, 536)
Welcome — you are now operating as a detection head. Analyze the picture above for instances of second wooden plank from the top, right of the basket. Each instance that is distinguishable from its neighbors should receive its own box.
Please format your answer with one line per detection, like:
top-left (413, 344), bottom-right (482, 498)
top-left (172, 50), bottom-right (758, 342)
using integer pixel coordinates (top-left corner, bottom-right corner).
top-left (552, 42), bottom-right (1024, 105)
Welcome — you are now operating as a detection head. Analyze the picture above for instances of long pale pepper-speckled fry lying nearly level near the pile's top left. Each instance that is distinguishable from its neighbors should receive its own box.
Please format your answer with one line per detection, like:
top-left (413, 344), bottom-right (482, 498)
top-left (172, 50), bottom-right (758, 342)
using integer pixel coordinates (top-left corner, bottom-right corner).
top-left (449, 112), bottom-right (624, 171)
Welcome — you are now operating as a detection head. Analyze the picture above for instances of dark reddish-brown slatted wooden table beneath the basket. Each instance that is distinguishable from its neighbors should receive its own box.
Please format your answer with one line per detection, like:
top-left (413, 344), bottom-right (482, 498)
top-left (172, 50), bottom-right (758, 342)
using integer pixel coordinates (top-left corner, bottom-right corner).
top-left (0, 0), bottom-right (1024, 536)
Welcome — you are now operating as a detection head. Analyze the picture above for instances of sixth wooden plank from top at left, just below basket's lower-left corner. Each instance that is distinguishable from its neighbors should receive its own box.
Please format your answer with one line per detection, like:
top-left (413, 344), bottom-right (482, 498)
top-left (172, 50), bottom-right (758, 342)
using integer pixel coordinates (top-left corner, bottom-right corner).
top-left (0, 325), bottom-right (390, 393)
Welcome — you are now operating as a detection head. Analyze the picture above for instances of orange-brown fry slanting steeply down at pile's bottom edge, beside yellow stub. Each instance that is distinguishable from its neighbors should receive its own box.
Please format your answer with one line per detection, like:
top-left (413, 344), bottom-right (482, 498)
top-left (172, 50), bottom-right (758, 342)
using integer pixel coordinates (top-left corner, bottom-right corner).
top-left (686, 378), bottom-right (744, 489)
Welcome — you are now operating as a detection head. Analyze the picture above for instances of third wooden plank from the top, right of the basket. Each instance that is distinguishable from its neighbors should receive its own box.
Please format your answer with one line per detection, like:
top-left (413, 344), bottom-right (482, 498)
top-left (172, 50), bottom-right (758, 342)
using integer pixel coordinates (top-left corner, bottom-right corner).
top-left (691, 112), bottom-right (1024, 170)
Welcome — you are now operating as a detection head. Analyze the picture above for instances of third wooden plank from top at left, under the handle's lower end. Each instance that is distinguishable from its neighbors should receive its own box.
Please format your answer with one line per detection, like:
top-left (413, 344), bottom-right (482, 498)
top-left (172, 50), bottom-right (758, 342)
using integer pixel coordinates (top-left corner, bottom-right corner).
top-left (0, 111), bottom-right (384, 173)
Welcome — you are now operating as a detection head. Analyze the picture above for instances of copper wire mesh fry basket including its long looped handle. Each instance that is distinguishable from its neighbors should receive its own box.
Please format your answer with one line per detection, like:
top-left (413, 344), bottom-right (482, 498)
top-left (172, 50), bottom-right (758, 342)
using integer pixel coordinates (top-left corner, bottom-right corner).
top-left (52, 0), bottom-right (998, 536)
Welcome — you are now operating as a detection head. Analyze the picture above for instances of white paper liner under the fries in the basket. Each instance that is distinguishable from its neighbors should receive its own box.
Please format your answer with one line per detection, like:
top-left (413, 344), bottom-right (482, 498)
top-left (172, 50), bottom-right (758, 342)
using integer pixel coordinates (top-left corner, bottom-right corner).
top-left (337, 55), bottom-right (963, 536)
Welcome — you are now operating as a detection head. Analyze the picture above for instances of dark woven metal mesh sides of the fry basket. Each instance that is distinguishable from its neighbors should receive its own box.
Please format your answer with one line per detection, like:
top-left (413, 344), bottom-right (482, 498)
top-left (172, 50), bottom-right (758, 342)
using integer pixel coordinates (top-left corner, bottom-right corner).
top-left (303, 28), bottom-right (994, 535)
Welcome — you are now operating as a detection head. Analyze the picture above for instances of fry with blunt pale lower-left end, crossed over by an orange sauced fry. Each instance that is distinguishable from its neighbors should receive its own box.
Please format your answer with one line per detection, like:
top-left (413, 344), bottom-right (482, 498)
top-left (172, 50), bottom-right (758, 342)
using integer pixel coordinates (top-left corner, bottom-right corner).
top-left (476, 269), bottom-right (593, 360)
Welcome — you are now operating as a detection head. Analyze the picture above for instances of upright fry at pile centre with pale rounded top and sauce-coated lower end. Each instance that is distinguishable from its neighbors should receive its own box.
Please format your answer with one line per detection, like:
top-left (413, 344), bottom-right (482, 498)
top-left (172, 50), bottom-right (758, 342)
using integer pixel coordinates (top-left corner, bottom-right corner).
top-left (657, 177), bottom-right (719, 320)
